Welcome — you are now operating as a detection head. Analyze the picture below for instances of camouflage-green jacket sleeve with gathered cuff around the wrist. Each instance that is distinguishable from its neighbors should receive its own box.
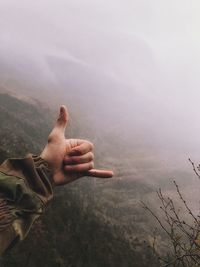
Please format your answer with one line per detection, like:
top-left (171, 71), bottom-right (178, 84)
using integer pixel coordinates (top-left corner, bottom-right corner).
top-left (0, 155), bottom-right (53, 255)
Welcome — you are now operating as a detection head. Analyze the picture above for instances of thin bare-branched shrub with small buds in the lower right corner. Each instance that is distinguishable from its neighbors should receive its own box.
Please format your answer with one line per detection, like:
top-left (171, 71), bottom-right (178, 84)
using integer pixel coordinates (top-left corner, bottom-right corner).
top-left (142, 159), bottom-right (200, 267)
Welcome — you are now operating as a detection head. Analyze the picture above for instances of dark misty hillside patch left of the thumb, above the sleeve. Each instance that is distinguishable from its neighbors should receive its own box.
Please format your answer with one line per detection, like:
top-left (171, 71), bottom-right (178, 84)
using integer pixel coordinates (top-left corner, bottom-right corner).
top-left (0, 93), bottom-right (51, 161)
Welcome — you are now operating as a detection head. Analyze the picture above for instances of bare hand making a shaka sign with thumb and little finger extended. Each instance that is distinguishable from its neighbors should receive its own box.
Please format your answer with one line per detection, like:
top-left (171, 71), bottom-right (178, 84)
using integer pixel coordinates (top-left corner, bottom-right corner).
top-left (41, 106), bottom-right (113, 185)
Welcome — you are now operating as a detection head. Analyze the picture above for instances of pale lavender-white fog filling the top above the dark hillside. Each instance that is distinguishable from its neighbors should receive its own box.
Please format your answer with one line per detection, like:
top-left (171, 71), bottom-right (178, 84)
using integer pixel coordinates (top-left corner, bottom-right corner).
top-left (0, 0), bottom-right (200, 170)
